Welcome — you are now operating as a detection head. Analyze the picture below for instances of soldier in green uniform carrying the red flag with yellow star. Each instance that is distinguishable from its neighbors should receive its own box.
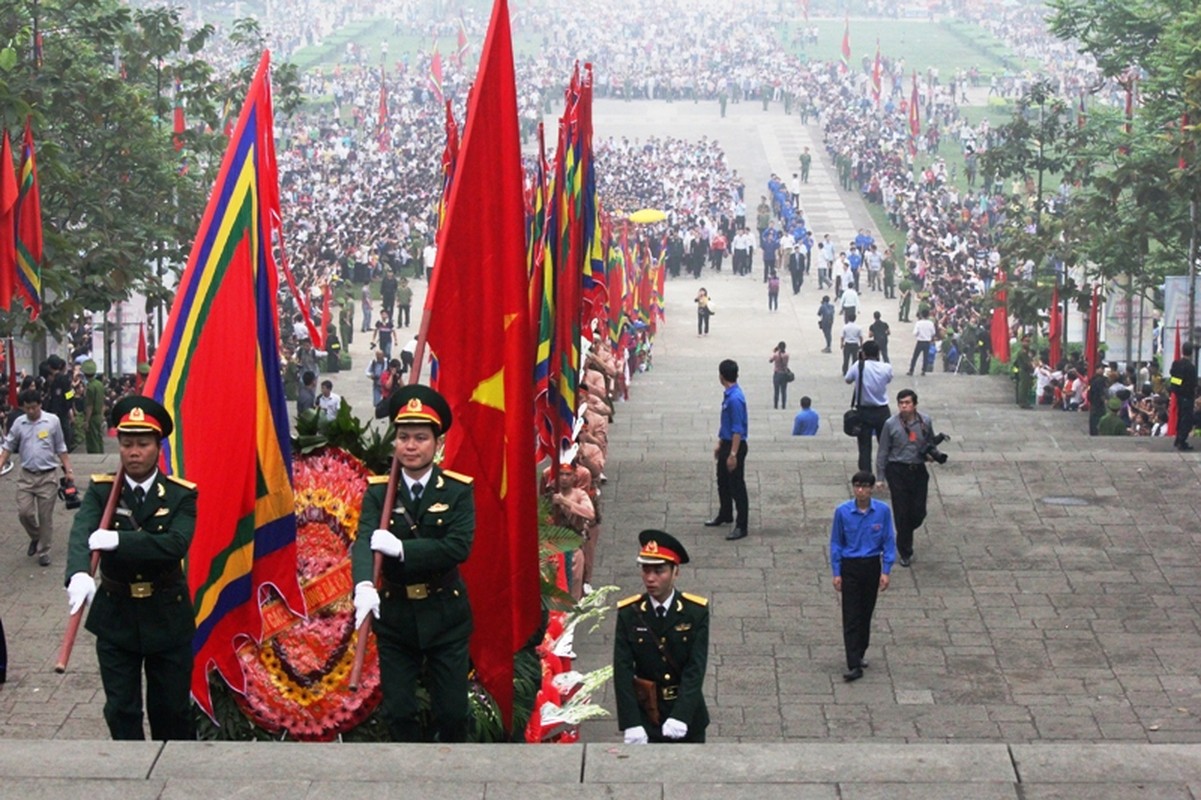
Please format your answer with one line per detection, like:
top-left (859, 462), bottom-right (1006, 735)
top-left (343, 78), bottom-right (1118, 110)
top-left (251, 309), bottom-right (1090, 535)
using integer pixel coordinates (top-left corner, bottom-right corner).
top-left (352, 384), bottom-right (476, 742)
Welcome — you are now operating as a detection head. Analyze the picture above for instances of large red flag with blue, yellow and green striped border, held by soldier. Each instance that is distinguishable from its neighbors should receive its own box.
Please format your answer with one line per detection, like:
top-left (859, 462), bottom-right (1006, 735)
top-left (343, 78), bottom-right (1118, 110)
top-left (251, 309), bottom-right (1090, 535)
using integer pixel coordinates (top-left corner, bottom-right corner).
top-left (145, 52), bottom-right (305, 716)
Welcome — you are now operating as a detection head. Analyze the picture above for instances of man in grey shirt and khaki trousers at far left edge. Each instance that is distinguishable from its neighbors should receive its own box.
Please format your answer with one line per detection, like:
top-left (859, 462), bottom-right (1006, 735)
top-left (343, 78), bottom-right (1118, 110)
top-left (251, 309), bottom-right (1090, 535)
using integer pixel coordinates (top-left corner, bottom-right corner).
top-left (0, 389), bottom-right (74, 567)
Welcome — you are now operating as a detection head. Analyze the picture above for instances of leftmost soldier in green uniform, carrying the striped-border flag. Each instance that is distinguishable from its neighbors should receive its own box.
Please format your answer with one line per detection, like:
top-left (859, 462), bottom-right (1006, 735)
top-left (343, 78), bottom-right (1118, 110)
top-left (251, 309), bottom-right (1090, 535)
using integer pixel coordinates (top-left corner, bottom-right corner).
top-left (66, 395), bottom-right (196, 741)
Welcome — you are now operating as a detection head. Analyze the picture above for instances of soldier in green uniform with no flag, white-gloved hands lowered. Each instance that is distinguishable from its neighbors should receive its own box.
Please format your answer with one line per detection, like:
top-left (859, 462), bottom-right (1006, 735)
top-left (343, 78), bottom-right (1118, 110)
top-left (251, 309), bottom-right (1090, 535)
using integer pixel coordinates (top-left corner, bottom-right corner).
top-left (613, 531), bottom-right (709, 745)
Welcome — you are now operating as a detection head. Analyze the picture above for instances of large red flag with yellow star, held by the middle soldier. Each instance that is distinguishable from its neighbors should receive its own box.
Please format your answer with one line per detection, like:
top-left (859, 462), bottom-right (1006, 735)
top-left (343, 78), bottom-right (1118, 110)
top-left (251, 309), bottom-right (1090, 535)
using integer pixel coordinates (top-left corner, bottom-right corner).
top-left (424, 0), bottom-right (542, 728)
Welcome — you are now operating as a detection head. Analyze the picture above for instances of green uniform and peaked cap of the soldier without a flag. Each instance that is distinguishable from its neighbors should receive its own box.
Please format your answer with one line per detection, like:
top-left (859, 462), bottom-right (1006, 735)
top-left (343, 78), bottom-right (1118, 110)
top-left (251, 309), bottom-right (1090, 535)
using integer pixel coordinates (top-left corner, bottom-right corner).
top-left (613, 531), bottom-right (709, 744)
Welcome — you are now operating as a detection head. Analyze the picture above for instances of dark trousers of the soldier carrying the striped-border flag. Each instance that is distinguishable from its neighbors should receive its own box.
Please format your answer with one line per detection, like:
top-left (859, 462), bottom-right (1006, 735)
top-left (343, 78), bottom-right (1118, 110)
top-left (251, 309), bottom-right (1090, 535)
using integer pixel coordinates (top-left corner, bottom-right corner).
top-left (96, 639), bottom-right (196, 741)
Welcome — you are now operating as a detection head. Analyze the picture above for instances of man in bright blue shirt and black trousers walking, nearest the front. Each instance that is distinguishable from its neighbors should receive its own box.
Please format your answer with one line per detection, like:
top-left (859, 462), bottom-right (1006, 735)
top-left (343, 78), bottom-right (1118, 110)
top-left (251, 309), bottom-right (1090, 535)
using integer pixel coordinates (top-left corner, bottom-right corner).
top-left (830, 471), bottom-right (897, 681)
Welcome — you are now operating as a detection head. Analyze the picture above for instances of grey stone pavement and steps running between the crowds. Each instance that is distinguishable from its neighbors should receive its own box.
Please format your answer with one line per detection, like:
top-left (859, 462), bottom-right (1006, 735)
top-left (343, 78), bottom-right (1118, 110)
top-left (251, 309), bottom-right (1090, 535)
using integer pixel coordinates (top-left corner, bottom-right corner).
top-left (0, 96), bottom-right (1201, 799)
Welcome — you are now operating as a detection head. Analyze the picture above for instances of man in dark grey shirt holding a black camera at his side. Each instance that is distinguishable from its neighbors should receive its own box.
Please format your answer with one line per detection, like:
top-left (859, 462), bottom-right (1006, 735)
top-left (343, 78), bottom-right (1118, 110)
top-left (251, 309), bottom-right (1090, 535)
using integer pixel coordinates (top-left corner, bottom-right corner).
top-left (876, 389), bottom-right (948, 567)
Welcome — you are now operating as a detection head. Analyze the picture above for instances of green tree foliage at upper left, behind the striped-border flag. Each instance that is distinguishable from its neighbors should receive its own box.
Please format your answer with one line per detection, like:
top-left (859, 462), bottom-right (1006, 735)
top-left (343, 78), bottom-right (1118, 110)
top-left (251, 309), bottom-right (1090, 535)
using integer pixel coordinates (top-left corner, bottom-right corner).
top-left (0, 0), bottom-right (299, 333)
